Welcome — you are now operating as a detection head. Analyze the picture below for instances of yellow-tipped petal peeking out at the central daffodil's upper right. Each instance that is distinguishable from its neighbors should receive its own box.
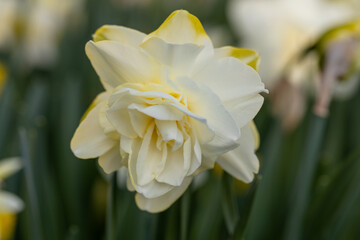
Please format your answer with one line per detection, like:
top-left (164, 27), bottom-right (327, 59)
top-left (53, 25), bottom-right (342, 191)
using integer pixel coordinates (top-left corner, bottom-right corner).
top-left (215, 46), bottom-right (260, 71)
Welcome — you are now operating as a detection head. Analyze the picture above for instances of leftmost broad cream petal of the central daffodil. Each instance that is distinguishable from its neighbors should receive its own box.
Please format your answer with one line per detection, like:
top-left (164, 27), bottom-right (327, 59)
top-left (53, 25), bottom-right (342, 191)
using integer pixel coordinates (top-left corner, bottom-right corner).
top-left (71, 101), bottom-right (116, 158)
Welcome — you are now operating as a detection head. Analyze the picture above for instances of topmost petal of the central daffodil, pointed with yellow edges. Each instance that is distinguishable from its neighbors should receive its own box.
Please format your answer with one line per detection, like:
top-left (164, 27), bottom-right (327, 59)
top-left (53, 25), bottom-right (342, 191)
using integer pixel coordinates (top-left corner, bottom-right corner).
top-left (145, 10), bottom-right (212, 46)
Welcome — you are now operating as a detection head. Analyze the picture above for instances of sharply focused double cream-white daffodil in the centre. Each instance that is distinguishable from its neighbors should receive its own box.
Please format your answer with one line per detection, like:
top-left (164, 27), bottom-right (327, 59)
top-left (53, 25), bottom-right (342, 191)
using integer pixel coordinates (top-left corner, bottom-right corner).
top-left (71, 10), bottom-right (267, 212)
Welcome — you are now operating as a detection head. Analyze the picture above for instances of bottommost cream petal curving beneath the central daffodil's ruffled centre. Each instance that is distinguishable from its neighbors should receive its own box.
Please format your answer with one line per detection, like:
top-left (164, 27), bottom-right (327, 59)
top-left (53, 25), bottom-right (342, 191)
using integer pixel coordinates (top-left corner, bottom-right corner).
top-left (135, 177), bottom-right (192, 213)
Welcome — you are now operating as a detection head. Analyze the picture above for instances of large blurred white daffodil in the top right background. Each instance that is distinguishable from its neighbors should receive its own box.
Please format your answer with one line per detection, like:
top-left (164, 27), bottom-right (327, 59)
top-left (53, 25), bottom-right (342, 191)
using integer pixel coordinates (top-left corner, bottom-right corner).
top-left (228, 0), bottom-right (358, 89)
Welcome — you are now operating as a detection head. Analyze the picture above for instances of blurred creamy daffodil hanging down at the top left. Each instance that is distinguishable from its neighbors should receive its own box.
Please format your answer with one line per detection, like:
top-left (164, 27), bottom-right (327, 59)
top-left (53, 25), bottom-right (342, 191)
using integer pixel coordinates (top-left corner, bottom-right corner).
top-left (21, 0), bottom-right (83, 67)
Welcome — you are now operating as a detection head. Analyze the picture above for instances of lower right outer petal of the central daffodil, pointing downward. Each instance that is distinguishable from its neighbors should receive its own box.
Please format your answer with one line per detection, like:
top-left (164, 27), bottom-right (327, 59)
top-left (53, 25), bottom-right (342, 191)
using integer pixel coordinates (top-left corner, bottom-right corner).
top-left (217, 124), bottom-right (259, 183)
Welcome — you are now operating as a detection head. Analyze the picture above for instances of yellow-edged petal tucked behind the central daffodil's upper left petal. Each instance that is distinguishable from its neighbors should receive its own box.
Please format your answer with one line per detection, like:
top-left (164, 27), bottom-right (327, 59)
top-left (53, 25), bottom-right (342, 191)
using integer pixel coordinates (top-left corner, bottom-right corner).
top-left (93, 25), bottom-right (146, 47)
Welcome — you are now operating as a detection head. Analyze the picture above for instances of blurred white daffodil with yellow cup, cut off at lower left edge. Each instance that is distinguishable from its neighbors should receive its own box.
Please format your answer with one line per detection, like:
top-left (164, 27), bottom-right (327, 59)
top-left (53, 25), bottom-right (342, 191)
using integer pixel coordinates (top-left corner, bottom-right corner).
top-left (0, 158), bottom-right (24, 240)
